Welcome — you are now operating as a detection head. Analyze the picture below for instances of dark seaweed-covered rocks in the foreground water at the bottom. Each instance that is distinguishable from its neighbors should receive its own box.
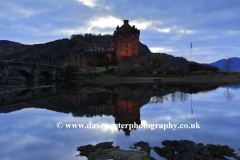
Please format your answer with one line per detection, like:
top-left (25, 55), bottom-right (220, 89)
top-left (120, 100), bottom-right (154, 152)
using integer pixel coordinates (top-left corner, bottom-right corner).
top-left (77, 140), bottom-right (240, 160)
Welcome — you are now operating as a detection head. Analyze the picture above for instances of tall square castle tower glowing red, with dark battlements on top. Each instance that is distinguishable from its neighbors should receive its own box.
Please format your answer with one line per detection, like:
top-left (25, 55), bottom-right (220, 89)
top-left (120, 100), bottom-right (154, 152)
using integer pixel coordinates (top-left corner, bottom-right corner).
top-left (114, 20), bottom-right (140, 62)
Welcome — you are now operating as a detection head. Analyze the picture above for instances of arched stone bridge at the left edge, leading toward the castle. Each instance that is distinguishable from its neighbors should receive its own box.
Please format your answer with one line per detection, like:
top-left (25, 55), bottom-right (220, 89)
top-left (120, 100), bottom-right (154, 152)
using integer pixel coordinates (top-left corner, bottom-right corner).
top-left (0, 62), bottom-right (61, 81)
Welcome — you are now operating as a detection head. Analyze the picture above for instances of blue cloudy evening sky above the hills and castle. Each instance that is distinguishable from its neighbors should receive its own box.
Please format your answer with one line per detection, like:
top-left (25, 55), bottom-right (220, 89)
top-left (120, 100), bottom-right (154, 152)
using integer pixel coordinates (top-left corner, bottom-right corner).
top-left (0, 0), bottom-right (240, 63)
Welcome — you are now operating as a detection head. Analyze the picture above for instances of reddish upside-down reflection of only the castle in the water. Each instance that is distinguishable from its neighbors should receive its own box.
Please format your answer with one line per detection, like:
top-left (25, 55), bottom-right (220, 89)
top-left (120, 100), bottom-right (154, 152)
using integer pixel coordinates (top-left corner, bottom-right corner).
top-left (77, 91), bottom-right (151, 135)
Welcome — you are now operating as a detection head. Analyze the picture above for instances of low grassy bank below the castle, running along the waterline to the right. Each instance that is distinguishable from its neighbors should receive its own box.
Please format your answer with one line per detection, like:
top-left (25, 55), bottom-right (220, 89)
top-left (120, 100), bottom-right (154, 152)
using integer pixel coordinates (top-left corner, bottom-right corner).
top-left (78, 66), bottom-right (240, 84)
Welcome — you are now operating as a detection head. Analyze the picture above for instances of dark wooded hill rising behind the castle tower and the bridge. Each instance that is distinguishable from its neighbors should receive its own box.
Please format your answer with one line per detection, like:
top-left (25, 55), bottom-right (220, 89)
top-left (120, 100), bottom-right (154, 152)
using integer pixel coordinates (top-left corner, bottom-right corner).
top-left (0, 34), bottom-right (150, 65)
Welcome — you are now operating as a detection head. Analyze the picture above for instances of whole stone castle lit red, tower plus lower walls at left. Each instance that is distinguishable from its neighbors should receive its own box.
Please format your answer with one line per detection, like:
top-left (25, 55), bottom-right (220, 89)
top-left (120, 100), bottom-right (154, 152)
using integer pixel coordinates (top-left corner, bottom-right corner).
top-left (71, 20), bottom-right (140, 68)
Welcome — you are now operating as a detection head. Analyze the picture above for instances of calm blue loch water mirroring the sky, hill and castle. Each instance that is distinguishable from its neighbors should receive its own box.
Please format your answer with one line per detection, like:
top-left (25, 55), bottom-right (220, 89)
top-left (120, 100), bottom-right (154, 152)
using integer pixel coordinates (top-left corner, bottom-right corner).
top-left (0, 84), bottom-right (240, 160)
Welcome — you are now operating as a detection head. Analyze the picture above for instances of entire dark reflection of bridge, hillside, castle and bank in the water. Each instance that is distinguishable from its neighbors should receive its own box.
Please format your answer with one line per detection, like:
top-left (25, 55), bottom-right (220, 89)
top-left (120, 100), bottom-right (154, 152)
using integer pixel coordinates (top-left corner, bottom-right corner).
top-left (0, 84), bottom-right (231, 136)
